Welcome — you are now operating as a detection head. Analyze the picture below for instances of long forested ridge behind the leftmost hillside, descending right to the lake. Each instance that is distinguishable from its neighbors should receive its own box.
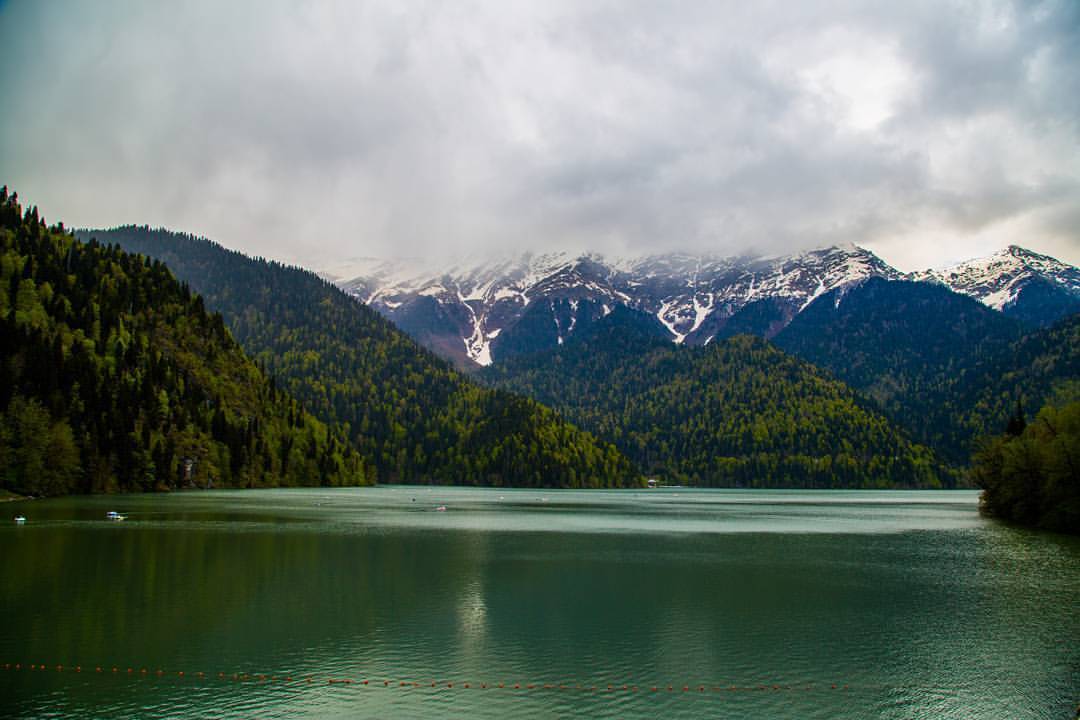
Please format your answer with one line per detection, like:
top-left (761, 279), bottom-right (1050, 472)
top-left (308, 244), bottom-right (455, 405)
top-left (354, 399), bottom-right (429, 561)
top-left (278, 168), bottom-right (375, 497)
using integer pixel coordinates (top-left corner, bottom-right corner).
top-left (83, 227), bottom-right (639, 487)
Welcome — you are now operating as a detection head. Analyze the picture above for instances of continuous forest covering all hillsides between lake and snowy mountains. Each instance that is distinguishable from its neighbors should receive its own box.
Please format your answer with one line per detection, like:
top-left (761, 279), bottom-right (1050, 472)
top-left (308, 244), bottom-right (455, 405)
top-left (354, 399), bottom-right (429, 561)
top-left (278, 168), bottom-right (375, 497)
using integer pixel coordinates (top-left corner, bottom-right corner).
top-left (0, 188), bottom-right (1080, 498)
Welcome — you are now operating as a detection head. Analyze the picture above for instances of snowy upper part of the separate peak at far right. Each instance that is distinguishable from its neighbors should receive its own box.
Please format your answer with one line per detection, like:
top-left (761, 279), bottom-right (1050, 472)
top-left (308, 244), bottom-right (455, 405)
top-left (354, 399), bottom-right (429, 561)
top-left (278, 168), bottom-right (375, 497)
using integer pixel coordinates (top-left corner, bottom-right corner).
top-left (913, 245), bottom-right (1080, 314)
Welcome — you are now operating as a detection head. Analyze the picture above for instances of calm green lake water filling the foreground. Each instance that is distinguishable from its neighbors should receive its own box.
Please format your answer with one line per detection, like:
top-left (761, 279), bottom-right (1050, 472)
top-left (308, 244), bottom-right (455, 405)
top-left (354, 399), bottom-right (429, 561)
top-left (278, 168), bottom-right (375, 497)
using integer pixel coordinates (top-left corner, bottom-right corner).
top-left (0, 487), bottom-right (1080, 720)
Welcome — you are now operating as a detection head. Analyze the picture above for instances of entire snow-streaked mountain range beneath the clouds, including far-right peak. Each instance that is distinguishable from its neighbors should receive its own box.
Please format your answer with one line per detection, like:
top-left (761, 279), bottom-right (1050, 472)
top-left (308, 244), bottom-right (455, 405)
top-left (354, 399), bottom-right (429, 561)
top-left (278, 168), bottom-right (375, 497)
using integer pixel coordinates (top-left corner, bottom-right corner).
top-left (323, 245), bottom-right (1080, 368)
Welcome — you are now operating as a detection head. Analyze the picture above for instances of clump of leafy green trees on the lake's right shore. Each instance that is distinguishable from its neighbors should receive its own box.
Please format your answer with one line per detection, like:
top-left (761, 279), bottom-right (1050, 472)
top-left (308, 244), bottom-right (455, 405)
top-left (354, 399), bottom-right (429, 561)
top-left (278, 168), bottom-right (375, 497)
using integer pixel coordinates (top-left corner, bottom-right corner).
top-left (972, 402), bottom-right (1080, 533)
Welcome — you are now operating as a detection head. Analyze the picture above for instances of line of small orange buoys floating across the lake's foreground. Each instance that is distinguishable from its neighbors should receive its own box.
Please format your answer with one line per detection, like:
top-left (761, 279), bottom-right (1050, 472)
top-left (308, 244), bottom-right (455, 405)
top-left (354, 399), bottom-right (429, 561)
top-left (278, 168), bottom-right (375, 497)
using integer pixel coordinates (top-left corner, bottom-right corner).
top-left (0, 663), bottom-right (850, 693)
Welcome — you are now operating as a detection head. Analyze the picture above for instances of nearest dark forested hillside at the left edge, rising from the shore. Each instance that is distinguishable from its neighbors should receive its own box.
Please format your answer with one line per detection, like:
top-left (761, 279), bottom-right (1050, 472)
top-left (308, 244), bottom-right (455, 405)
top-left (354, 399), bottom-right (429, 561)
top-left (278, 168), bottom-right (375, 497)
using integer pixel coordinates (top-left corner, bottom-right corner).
top-left (0, 187), bottom-right (374, 494)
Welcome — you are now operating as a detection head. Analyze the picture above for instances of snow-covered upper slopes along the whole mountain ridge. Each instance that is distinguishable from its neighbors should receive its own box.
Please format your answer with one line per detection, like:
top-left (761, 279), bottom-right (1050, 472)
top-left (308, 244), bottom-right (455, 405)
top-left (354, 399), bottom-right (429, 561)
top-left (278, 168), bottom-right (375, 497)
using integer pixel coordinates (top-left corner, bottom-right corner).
top-left (326, 244), bottom-right (1080, 365)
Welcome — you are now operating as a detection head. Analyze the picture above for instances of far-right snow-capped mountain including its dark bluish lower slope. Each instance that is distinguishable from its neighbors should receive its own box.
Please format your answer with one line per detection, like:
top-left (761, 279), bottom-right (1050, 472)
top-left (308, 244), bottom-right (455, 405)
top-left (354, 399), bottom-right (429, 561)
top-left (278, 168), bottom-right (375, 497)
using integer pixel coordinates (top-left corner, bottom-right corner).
top-left (912, 245), bottom-right (1080, 325)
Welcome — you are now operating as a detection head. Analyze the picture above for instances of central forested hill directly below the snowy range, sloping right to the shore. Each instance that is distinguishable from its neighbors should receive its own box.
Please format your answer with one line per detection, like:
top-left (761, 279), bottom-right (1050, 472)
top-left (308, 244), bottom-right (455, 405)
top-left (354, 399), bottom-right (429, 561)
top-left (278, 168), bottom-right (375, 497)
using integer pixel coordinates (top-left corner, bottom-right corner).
top-left (481, 308), bottom-right (954, 488)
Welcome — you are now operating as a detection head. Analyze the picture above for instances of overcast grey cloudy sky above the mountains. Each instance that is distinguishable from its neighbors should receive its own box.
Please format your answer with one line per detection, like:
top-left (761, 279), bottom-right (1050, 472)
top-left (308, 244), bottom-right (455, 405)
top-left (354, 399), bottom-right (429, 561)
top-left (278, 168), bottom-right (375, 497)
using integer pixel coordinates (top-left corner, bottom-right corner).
top-left (0, 0), bottom-right (1080, 270)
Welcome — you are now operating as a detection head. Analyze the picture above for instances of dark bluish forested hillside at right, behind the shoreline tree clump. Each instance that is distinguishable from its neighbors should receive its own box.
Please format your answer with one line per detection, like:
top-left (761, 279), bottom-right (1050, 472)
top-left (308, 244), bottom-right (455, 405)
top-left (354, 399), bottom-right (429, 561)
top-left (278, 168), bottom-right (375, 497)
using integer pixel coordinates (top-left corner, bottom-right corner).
top-left (773, 279), bottom-right (1080, 465)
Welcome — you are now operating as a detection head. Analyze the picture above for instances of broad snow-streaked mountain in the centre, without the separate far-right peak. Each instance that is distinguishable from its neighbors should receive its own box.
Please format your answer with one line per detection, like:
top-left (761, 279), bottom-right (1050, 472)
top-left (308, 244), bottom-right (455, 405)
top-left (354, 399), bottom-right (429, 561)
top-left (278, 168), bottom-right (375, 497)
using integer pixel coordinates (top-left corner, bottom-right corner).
top-left (325, 245), bottom-right (902, 365)
